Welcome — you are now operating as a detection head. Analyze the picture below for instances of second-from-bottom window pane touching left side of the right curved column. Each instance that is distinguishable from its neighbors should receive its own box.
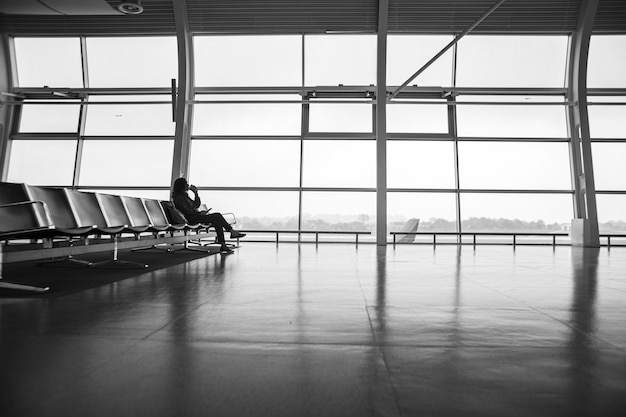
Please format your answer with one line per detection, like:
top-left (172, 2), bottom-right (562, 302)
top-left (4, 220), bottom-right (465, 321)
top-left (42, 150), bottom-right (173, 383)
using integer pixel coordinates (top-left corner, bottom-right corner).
top-left (459, 142), bottom-right (571, 190)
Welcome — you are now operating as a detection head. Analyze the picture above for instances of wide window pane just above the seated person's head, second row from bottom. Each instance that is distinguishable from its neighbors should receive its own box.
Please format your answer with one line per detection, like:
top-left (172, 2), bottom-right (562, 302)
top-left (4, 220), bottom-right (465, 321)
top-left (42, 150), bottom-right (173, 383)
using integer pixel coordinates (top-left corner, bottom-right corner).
top-left (190, 139), bottom-right (300, 187)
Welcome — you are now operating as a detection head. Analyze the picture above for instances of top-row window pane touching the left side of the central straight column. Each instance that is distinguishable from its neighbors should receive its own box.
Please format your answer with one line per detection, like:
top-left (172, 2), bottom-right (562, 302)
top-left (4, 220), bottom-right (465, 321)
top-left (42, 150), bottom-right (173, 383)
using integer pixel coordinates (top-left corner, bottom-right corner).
top-left (304, 35), bottom-right (376, 86)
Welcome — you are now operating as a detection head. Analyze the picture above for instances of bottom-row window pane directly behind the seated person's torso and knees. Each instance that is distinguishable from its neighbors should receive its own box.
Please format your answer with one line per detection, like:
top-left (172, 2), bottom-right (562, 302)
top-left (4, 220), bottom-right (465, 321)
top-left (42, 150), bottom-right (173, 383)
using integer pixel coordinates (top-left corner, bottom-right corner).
top-left (199, 190), bottom-right (298, 230)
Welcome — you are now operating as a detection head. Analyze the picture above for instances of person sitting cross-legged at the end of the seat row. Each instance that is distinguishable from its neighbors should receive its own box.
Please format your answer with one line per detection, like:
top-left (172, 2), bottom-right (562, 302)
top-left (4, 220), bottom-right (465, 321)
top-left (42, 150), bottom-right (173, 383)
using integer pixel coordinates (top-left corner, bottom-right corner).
top-left (172, 178), bottom-right (246, 252)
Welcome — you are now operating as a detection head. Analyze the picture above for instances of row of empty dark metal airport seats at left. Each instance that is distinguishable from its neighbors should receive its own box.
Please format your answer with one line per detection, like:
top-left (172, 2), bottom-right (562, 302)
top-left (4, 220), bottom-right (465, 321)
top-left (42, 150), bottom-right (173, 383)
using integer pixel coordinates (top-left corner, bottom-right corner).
top-left (0, 182), bottom-right (217, 261)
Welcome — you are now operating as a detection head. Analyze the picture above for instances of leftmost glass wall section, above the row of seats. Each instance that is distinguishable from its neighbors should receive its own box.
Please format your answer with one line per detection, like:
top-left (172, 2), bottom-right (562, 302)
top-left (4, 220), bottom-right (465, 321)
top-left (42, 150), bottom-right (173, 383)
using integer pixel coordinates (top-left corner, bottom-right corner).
top-left (7, 37), bottom-right (178, 198)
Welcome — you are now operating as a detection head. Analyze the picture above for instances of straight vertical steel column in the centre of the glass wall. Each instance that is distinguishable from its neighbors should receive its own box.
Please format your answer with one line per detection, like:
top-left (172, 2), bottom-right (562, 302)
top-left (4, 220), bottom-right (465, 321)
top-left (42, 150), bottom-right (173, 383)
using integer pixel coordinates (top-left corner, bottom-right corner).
top-left (376, 0), bottom-right (389, 246)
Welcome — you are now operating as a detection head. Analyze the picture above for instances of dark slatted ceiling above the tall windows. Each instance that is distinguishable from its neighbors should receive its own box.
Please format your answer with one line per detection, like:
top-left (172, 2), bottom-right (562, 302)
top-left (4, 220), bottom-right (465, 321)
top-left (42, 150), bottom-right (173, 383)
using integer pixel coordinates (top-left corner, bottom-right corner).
top-left (0, 0), bottom-right (626, 35)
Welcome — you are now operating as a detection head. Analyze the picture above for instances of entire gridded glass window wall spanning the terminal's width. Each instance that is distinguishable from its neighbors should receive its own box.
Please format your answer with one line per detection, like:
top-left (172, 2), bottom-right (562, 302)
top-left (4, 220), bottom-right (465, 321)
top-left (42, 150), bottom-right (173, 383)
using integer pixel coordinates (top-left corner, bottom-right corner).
top-left (7, 34), bottom-right (626, 239)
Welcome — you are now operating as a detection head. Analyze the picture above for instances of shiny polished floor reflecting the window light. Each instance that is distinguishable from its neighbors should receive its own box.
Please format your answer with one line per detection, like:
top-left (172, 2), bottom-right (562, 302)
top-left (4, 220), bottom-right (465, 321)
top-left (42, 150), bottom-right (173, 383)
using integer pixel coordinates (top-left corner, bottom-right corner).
top-left (0, 242), bottom-right (626, 417)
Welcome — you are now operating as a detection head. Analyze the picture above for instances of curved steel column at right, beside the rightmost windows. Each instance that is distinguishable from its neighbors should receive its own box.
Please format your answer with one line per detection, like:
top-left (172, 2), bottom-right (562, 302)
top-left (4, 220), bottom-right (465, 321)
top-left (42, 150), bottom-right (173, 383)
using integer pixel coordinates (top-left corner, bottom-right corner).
top-left (567, 0), bottom-right (600, 247)
